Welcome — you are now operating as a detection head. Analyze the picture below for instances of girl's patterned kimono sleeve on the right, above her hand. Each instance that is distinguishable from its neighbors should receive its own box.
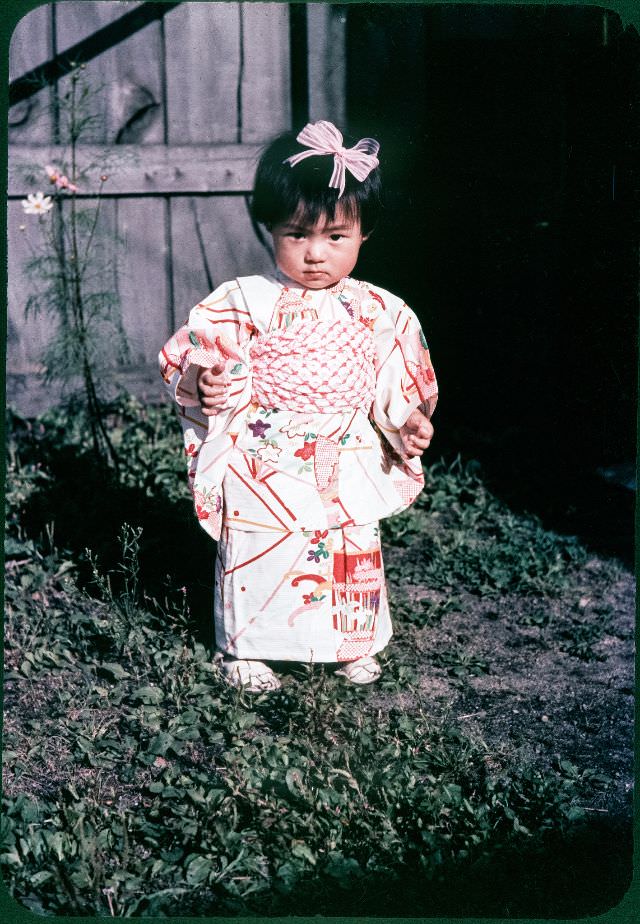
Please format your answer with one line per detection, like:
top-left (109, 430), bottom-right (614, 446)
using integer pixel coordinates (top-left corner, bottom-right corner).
top-left (371, 293), bottom-right (438, 453)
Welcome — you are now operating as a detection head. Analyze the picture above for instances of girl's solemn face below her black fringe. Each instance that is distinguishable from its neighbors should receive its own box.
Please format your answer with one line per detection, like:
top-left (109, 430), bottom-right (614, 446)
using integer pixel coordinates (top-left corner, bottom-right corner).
top-left (271, 208), bottom-right (367, 289)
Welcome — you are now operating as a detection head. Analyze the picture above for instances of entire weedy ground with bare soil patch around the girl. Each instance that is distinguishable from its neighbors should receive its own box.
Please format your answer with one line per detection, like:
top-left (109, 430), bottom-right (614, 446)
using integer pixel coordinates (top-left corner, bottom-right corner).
top-left (0, 402), bottom-right (635, 917)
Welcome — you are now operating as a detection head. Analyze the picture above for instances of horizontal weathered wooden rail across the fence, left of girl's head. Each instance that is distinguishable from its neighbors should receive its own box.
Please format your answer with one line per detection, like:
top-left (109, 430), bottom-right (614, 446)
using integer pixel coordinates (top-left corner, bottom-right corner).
top-left (9, 144), bottom-right (261, 196)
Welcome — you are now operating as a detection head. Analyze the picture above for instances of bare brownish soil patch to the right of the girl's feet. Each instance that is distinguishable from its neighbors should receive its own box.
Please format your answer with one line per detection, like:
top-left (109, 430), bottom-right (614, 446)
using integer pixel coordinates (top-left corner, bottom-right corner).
top-left (381, 549), bottom-right (635, 819)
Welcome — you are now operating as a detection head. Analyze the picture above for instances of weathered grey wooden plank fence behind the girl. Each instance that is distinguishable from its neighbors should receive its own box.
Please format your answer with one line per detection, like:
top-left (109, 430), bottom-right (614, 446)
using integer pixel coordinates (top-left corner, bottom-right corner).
top-left (7, 0), bottom-right (345, 415)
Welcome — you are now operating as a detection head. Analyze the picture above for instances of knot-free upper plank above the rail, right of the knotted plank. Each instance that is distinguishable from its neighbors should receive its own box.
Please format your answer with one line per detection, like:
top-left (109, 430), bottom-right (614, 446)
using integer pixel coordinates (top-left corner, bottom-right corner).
top-left (164, 3), bottom-right (241, 144)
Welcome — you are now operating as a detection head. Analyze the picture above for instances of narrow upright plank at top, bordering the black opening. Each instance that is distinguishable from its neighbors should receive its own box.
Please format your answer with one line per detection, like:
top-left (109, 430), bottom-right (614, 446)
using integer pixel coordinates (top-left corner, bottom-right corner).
top-left (307, 3), bottom-right (347, 130)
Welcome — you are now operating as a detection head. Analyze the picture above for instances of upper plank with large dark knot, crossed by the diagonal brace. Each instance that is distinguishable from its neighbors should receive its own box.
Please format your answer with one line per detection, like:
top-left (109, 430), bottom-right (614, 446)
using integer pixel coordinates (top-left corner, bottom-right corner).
top-left (56, 0), bottom-right (164, 144)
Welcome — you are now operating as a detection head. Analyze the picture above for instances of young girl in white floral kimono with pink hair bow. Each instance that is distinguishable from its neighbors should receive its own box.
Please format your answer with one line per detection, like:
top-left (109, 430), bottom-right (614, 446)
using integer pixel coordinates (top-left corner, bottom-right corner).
top-left (160, 122), bottom-right (437, 691)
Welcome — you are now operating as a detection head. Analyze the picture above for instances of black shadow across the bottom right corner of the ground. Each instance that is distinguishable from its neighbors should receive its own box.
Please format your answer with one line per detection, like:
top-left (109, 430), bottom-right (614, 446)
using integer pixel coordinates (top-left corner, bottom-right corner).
top-left (176, 818), bottom-right (632, 919)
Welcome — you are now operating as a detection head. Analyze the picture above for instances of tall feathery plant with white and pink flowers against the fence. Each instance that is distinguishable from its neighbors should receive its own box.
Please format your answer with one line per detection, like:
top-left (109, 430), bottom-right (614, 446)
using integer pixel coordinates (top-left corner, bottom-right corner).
top-left (15, 65), bottom-right (128, 468)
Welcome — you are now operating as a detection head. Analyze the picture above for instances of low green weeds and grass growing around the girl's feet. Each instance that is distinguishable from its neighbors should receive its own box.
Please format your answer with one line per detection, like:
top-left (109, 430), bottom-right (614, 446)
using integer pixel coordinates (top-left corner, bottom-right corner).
top-left (0, 400), bottom-right (632, 916)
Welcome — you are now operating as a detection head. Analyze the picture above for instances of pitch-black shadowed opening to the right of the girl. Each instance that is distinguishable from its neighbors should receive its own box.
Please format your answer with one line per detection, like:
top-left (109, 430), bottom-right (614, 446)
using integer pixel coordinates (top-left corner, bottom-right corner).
top-left (344, 3), bottom-right (640, 559)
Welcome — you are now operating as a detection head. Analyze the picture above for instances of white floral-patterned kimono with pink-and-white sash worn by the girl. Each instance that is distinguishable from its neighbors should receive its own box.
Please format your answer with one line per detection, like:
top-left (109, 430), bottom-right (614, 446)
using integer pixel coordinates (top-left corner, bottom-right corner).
top-left (159, 275), bottom-right (437, 662)
